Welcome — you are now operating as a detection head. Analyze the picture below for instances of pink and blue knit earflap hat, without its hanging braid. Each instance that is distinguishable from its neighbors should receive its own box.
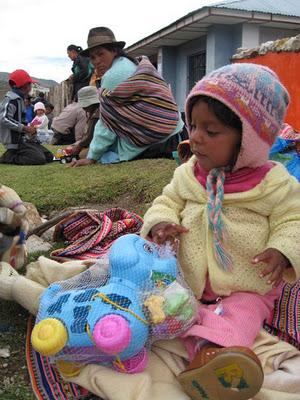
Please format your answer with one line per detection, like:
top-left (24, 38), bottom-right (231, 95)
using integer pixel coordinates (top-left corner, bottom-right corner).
top-left (186, 63), bottom-right (289, 171)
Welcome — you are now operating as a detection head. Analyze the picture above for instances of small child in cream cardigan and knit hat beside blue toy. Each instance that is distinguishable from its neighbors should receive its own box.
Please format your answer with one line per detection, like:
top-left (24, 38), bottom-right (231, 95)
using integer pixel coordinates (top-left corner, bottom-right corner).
top-left (142, 64), bottom-right (300, 399)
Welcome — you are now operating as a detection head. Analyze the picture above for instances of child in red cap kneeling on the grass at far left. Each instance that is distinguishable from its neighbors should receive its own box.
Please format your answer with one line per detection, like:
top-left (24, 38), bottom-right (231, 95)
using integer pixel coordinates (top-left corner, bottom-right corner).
top-left (0, 69), bottom-right (53, 165)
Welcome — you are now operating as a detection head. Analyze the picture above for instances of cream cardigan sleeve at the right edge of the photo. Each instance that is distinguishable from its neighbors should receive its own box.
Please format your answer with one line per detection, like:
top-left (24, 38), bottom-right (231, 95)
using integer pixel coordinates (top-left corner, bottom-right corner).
top-left (267, 177), bottom-right (300, 282)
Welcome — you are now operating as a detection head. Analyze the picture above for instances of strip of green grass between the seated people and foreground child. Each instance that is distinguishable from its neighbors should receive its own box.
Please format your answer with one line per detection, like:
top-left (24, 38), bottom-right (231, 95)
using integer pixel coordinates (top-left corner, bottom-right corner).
top-left (0, 145), bottom-right (175, 214)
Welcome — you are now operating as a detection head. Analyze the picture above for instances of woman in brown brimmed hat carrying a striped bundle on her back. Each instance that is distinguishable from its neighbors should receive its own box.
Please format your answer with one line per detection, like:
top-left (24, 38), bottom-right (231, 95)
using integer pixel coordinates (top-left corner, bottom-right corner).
top-left (73, 27), bottom-right (184, 167)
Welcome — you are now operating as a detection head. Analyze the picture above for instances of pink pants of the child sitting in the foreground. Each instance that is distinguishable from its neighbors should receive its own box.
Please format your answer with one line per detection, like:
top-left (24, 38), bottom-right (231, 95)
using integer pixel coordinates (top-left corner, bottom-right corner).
top-left (183, 280), bottom-right (282, 358)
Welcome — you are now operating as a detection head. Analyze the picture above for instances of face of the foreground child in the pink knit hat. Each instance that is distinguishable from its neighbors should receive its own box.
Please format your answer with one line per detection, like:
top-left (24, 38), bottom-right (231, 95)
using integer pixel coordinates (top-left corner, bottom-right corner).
top-left (190, 100), bottom-right (240, 172)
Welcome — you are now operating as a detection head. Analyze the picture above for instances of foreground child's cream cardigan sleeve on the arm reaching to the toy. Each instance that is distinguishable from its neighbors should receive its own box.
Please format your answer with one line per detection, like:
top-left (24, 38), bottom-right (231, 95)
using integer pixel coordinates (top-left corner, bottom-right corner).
top-left (141, 165), bottom-right (185, 237)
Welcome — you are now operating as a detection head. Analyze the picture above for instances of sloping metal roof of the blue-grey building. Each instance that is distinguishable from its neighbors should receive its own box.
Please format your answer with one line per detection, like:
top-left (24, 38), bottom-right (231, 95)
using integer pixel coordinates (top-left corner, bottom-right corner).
top-left (126, 0), bottom-right (300, 56)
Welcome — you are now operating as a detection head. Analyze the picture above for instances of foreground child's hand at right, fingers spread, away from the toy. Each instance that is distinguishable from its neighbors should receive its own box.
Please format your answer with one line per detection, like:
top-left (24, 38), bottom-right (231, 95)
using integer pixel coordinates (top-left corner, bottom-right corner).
top-left (252, 249), bottom-right (291, 286)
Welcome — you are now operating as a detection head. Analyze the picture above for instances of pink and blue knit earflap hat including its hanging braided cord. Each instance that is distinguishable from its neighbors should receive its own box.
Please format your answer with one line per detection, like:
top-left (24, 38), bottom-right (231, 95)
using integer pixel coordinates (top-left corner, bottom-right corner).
top-left (186, 63), bottom-right (289, 270)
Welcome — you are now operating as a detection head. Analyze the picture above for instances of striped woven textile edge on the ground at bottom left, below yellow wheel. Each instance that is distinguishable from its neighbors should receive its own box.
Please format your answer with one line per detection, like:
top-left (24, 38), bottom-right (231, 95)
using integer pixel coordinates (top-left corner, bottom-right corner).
top-left (26, 316), bottom-right (94, 400)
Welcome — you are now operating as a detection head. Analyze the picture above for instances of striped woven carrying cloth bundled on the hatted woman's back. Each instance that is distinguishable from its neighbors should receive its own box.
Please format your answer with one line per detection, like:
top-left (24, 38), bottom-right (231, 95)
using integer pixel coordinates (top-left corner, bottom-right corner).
top-left (100, 56), bottom-right (179, 147)
